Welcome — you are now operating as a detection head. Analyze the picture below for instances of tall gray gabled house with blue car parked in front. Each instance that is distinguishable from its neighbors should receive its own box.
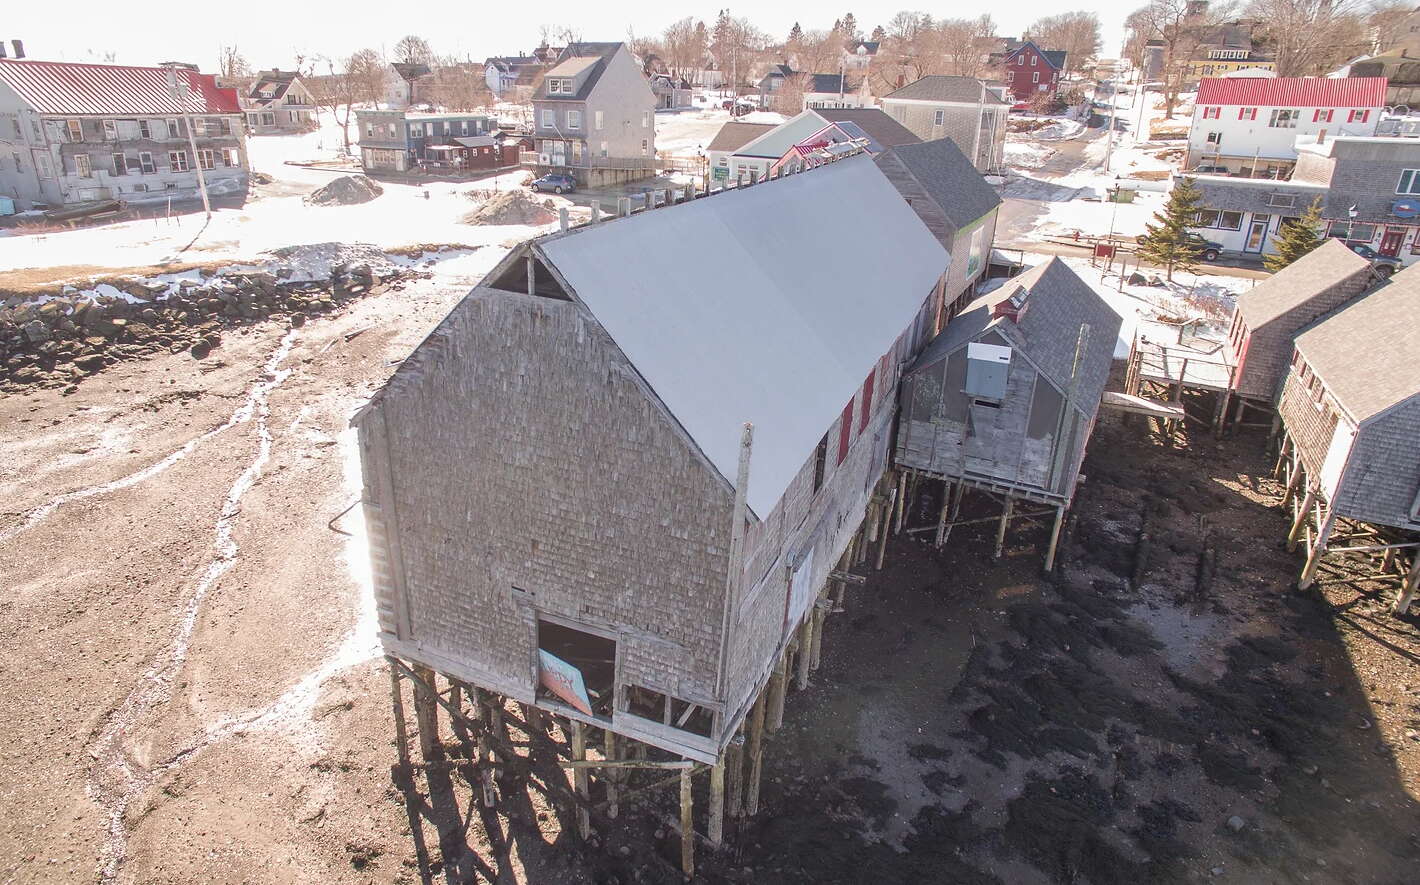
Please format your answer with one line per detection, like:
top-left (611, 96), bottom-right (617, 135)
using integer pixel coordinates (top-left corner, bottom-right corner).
top-left (533, 43), bottom-right (656, 188)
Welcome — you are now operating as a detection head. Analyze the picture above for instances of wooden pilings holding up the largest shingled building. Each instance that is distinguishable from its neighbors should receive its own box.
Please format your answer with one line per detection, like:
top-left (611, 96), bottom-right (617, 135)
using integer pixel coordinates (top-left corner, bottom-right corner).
top-left (385, 474), bottom-right (902, 876)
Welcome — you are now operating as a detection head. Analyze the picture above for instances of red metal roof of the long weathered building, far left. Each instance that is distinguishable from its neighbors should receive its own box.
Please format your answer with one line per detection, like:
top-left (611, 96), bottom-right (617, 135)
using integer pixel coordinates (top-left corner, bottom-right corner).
top-left (0, 58), bottom-right (241, 116)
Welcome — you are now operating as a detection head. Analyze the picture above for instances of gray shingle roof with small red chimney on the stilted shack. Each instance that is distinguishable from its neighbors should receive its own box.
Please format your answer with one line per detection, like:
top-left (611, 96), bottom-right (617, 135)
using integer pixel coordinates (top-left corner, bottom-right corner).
top-left (907, 259), bottom-right (1122, 416)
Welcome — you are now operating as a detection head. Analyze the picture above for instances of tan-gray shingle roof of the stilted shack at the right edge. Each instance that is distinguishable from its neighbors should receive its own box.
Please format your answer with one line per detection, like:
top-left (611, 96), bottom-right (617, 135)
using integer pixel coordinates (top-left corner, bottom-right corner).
top-left (1296, 267), bottom-right (1420, 422)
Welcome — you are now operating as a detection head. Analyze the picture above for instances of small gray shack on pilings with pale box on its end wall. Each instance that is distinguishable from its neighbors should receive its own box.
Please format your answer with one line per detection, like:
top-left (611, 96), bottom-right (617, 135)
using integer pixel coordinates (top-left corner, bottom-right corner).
top-left (896, 259), bottom-right (1120, 571)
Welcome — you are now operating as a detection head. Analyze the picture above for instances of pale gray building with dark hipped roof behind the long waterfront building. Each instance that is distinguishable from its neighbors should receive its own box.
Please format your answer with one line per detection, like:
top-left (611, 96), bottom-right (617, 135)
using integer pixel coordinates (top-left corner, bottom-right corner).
top-left (879, 74), bottom-right (1011, 175)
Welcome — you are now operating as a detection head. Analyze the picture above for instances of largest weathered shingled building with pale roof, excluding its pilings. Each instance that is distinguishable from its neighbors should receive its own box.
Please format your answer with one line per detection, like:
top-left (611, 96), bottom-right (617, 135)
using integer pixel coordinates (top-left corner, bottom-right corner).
top-left (355, 156), bottom-right (954, 789)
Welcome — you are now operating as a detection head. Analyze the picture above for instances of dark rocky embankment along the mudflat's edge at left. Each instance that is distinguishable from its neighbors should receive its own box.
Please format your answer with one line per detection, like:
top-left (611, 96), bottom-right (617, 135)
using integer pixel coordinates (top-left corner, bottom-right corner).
top-left (0, 243), bottom-right (426, 392)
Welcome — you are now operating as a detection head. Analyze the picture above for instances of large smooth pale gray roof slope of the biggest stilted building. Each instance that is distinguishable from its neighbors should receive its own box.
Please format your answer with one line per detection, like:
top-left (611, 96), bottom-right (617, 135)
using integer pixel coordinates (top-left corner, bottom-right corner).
top-left (541, 156), bottom-right (949, 517)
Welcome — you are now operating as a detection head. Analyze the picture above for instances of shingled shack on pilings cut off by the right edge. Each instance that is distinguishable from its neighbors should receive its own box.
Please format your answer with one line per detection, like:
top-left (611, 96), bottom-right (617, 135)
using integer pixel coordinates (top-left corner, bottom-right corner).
top-left (1275, 267), bottom-right (1420, 614)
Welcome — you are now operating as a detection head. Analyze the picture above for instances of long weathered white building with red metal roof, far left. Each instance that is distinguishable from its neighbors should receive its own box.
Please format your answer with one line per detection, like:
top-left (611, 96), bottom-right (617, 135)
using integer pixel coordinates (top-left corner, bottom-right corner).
top-left (0, 58), bottom-right (247, 209)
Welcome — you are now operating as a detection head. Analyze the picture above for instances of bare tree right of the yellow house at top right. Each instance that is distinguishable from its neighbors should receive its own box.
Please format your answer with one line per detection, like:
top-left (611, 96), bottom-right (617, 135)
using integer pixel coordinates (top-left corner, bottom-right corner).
top-left (1247, 0), bottom-right (1370, 77)
